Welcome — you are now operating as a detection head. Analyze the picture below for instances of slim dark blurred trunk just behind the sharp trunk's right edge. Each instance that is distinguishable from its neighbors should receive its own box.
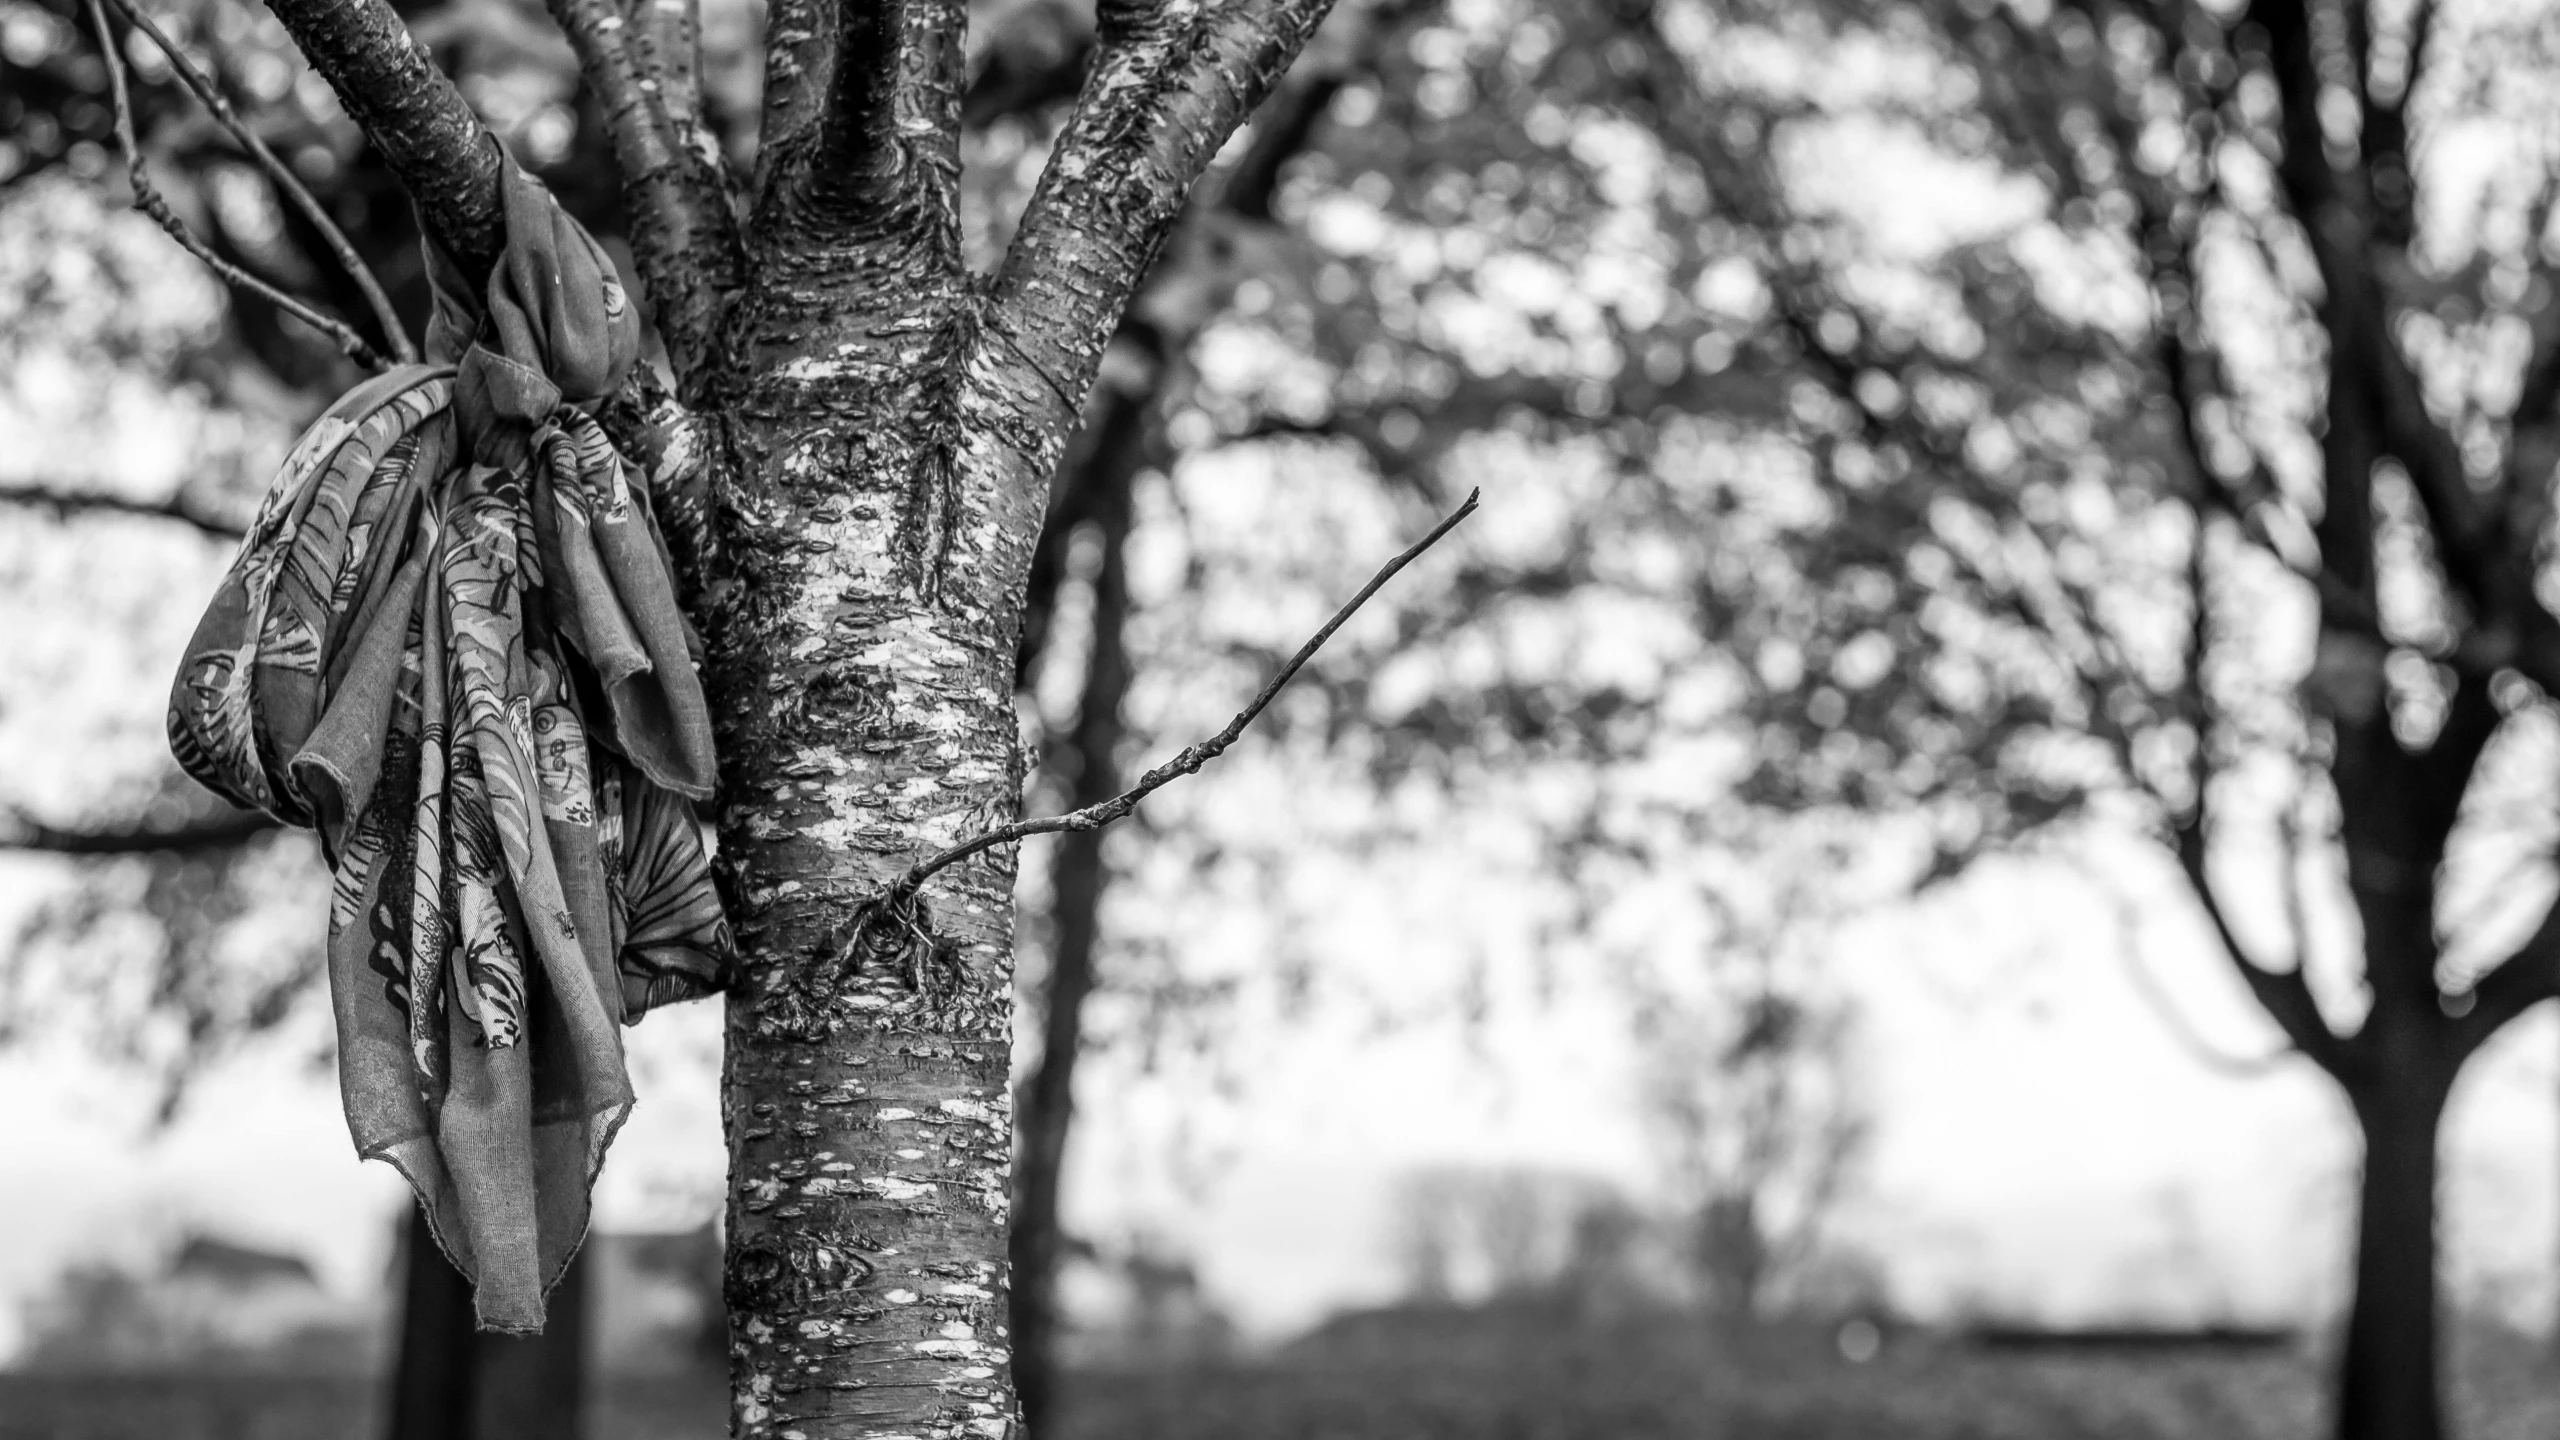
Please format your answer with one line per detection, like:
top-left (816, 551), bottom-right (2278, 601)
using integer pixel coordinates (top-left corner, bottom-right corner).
top-left (1011, 402), bottom-right (1147, 1437)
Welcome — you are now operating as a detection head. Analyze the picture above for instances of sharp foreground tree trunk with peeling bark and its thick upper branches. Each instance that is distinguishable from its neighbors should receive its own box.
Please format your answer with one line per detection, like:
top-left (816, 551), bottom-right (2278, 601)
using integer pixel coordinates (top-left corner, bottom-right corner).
top-left (157, 0), bottom-right (1331, 1440)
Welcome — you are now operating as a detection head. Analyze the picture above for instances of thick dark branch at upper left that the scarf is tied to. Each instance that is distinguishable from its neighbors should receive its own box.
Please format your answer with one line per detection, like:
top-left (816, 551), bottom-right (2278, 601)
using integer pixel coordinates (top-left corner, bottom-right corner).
top-left (266, 0), bottom-right (507, 274)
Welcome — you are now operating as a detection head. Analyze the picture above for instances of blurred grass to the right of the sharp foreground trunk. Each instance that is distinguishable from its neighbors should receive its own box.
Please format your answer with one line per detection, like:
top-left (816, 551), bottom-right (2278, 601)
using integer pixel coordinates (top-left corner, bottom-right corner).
top-left (1057, 1306), bottom-right (2560, 1440)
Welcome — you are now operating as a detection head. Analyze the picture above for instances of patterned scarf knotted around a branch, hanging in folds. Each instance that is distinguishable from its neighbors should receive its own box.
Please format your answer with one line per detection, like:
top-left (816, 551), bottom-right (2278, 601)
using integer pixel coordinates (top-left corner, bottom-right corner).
top-left (169, 151), bottom-right (732, 1332)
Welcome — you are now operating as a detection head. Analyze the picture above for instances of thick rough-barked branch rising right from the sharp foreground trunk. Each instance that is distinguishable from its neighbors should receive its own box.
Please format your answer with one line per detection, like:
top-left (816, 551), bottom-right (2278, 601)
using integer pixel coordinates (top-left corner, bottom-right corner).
top-left (978, 0), bottom-right (1331, 471)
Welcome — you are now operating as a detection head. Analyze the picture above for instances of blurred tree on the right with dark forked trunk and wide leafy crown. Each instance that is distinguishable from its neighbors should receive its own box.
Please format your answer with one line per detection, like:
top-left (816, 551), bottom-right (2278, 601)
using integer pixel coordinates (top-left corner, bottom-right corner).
top-left (1136, 3), bottom-right (2560, 1437)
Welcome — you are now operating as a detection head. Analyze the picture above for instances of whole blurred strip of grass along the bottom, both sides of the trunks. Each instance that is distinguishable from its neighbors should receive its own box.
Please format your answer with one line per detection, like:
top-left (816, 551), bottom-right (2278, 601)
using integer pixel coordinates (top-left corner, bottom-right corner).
top-left (0, 1317), bottom-right (2560, 1440)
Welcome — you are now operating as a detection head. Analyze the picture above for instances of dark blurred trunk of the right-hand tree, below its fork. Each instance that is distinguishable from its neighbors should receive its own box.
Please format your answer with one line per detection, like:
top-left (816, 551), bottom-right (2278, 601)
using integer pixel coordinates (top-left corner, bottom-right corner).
top-left (2337, 1040), bottom-right (2450, 1440)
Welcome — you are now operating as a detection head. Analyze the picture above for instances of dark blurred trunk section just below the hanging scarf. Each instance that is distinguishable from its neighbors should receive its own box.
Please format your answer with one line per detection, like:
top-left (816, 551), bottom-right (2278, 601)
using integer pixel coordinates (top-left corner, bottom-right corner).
top-left (387, 1207), bottom-right (589, 1440)
